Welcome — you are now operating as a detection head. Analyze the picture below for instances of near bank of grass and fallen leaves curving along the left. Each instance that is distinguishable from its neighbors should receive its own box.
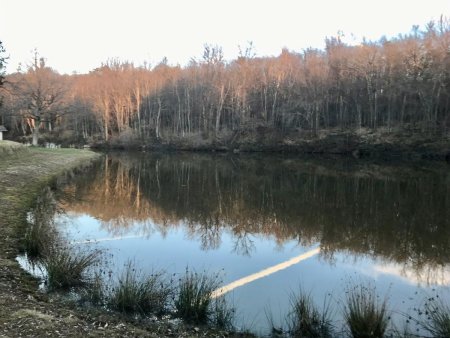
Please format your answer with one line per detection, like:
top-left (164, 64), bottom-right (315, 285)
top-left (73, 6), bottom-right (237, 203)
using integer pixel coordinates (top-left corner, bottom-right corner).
top-left (0, 141), bottom-right (239, 337)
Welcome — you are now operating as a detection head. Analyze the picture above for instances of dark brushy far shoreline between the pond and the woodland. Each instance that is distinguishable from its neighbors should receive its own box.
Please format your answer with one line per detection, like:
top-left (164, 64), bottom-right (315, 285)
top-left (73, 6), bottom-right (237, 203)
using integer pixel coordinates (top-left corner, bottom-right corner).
top-left (91, 130), bottom-right (450, 162)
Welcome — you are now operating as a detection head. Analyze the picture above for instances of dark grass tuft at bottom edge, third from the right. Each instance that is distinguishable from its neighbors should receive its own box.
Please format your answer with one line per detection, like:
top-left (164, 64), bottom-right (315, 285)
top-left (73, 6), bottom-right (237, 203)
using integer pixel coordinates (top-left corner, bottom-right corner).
top-left (287, 290), bottom-right (333, 338)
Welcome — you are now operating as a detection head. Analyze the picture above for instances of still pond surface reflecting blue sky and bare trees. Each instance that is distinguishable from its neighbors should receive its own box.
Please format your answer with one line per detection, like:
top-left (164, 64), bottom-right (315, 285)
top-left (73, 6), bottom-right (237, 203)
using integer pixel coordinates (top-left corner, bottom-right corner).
top-left (29, 153), bottom-right (450, 333)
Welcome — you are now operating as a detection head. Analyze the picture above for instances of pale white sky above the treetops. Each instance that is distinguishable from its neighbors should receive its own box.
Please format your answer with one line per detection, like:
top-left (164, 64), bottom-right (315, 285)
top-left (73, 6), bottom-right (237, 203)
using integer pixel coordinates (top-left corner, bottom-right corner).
top-left (0, 0), bottom-right (450, 74)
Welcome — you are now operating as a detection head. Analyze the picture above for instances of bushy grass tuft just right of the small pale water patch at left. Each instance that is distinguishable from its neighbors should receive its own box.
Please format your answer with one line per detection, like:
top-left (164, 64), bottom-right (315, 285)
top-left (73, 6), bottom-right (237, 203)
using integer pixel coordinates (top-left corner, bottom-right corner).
top-left (41, 247), bottom-right (100, 290)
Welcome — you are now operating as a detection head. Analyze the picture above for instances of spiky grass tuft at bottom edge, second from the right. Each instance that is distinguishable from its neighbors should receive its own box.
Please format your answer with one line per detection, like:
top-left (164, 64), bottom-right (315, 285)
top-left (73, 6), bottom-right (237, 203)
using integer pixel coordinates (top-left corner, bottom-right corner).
top-left (344, 284), bottom-right (390, 338)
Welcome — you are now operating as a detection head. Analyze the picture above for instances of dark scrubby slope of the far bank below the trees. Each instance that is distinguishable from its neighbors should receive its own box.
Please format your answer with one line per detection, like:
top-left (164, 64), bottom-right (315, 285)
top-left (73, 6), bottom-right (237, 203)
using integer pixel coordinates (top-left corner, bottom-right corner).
top-left (93, 126), bottom-right (450, 160)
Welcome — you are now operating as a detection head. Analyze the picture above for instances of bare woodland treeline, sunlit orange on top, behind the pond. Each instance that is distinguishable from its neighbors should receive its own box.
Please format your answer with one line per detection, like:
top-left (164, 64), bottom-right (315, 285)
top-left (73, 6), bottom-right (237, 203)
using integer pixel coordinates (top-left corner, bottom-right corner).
top-left (0, 18), bottom-right (450, 148)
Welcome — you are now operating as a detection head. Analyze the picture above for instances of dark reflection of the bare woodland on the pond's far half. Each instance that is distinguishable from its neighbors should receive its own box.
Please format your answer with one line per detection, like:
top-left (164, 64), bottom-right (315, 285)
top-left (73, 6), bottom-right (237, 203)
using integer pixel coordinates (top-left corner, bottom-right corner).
top-left (61, 154), bottom-right (450, 284)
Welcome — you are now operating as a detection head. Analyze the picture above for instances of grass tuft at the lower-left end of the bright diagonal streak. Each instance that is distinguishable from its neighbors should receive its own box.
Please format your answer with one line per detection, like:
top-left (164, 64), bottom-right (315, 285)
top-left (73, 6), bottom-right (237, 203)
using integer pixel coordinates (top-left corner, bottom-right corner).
top-left (175, 269), bottom-right (219, 324)
